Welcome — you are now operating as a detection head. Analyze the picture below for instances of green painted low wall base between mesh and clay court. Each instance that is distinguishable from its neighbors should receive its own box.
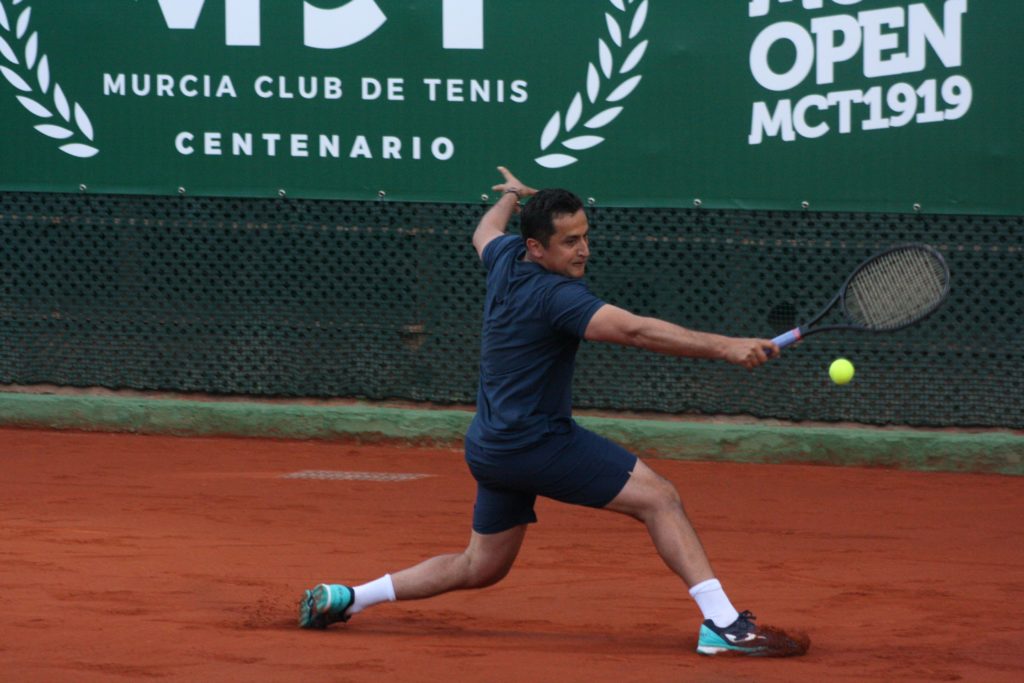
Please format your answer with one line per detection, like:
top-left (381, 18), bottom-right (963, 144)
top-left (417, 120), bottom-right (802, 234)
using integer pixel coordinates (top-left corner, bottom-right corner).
top-left (0, 393), bottom-right (1024, 475)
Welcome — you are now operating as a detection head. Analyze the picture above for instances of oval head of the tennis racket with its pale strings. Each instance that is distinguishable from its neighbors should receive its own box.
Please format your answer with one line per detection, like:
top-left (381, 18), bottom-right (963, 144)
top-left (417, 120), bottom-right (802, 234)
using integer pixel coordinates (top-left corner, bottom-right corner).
top-left (845, 248), bottom-right (948, 330)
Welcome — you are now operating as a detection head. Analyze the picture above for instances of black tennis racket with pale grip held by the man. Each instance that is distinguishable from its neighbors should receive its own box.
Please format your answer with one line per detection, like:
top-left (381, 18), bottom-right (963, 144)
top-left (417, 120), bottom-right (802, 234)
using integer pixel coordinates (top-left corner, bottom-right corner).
top-left (772, 244), bottom-right (949, 348)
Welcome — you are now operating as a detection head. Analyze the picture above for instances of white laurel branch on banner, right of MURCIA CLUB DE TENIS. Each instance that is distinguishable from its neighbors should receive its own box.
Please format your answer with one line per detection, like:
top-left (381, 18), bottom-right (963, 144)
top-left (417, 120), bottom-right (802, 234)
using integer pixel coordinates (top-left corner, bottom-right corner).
top-left (535, 0), bottom-right (649, 168)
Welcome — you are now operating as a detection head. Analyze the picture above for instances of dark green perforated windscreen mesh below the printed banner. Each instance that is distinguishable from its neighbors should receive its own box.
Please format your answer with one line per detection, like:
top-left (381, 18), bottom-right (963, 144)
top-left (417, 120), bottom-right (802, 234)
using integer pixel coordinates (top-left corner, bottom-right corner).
top-left (0, 193), bottom-right (1024, 428)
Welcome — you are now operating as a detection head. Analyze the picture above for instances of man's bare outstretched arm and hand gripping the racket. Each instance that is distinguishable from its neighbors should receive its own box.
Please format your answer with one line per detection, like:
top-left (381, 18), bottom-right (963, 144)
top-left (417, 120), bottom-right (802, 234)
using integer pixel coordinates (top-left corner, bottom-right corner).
top-left (584, 304), bottom-right (779, 368)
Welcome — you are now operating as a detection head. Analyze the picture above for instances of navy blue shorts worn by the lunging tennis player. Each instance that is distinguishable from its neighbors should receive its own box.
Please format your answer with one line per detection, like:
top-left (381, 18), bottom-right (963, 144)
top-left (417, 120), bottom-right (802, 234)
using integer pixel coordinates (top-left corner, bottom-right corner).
top-left (466, 423), bottom-right (637, 533)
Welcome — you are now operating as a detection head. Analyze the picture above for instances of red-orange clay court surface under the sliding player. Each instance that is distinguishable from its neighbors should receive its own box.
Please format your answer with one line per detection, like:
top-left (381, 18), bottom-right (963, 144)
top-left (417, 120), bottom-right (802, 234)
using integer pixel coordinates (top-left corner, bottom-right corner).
top-left (0, 429), bottom-right (1024, 683)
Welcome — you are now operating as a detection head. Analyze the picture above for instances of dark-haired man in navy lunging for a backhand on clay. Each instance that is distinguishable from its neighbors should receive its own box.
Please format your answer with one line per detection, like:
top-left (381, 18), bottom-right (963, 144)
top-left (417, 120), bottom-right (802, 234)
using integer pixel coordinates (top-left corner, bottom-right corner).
top-left (299, 167), bottom-right (806, 656)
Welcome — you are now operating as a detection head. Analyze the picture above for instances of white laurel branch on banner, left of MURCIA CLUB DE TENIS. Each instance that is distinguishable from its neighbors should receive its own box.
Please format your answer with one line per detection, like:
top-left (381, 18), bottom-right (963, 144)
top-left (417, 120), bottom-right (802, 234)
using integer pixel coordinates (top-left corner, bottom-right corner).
top-left (0, 0), bottom-right (99, 159)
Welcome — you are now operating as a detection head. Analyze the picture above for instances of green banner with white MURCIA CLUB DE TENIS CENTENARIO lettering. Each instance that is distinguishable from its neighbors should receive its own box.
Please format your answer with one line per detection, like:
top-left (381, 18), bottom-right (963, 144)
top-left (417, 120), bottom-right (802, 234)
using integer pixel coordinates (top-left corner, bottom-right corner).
top-left (0, 0), bottom-right (1024, 215)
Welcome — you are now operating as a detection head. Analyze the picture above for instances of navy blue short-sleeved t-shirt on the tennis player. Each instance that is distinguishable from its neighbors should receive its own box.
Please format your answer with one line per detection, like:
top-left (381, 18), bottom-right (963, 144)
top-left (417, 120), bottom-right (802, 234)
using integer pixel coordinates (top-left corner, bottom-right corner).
top-left (466, 234), bottom-right (604, 451)
